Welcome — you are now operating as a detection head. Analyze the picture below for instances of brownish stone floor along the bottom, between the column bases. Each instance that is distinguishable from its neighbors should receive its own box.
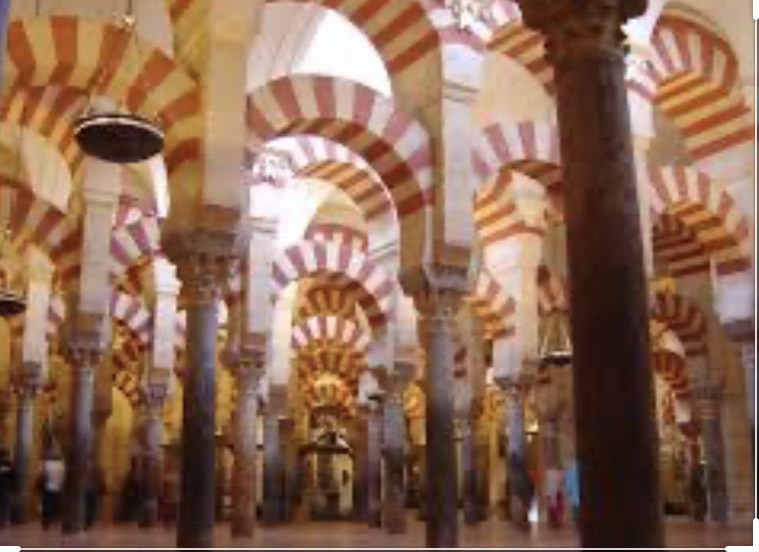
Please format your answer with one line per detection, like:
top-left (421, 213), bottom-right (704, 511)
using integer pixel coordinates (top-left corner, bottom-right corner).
top-left (0, 520), bottom-right (752, 549)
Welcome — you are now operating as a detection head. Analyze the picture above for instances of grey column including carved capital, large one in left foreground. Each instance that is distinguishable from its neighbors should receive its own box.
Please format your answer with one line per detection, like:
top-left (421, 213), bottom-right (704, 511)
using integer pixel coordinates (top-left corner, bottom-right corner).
top-left (163, 230), bottom-right (239, 548)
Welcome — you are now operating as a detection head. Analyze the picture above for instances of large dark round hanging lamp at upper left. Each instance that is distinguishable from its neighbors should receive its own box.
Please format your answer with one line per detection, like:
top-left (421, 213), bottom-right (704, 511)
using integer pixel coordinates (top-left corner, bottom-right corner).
top-left (74, 0), bottom-right (164, 164)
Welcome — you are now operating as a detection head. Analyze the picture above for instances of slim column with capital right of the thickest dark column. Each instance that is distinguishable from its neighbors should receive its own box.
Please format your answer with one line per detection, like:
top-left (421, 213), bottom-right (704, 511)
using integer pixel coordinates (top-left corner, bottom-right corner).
top-left (693, 385), bottom-right (728, 522)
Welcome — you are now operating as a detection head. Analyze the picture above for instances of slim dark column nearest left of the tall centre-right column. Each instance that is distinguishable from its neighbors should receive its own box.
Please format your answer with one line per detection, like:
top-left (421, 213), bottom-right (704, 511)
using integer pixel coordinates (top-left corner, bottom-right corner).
top-left (382, 383), bottom-right (407, 534)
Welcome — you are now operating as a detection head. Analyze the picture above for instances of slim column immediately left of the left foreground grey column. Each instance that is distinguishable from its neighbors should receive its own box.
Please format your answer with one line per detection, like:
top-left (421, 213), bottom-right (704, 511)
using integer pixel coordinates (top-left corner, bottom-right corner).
top-left (140, 380), bottom-right (169, 527)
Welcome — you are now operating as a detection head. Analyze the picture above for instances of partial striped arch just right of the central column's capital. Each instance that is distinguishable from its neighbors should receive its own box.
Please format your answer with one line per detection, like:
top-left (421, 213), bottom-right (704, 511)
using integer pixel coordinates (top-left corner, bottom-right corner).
top-left (469, 268), bottom-right (515, 339)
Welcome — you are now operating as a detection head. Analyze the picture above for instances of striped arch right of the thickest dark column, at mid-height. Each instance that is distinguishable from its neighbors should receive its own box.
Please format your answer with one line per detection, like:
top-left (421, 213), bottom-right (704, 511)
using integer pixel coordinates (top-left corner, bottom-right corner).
top-left (648, 165), bottom-right (752, 275)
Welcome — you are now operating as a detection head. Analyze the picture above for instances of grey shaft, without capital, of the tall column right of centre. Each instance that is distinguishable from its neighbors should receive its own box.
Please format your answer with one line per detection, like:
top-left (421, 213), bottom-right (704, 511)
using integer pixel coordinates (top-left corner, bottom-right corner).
top-left (424, 302), bottom-right (458, 548)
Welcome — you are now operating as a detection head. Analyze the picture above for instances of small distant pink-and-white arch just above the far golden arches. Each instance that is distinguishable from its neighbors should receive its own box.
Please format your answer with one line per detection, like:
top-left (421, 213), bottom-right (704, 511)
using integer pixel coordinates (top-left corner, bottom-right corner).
top-left (292, 316), bottom-right (371, 353)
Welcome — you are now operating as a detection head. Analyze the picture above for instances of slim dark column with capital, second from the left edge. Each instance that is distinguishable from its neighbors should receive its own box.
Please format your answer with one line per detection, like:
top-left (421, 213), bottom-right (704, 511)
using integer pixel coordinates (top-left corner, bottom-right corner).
top-left (61, 343), bottom-right (102, 533)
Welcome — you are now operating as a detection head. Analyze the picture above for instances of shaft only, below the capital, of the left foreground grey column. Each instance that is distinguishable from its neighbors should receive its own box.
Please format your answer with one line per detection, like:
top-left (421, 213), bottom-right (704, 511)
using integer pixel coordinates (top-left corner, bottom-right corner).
top-left (177, 297), bottom-right (218, 548)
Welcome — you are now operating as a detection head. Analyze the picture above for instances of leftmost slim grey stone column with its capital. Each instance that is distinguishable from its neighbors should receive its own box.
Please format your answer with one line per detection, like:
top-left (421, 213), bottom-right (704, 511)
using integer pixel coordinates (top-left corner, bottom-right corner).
top-left (14, 363), bottom-right (42, 523)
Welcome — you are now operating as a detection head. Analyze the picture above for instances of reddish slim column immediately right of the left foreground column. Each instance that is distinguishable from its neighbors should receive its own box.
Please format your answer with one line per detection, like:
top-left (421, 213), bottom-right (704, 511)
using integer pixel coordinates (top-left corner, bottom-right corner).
top-left (231, 351), bottom-right (264, 537)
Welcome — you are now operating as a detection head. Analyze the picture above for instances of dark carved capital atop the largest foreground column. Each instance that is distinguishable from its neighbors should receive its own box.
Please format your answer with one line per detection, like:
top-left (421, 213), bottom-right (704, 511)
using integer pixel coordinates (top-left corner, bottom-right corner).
top-left (517, 0), bottom-right (648, 65)
